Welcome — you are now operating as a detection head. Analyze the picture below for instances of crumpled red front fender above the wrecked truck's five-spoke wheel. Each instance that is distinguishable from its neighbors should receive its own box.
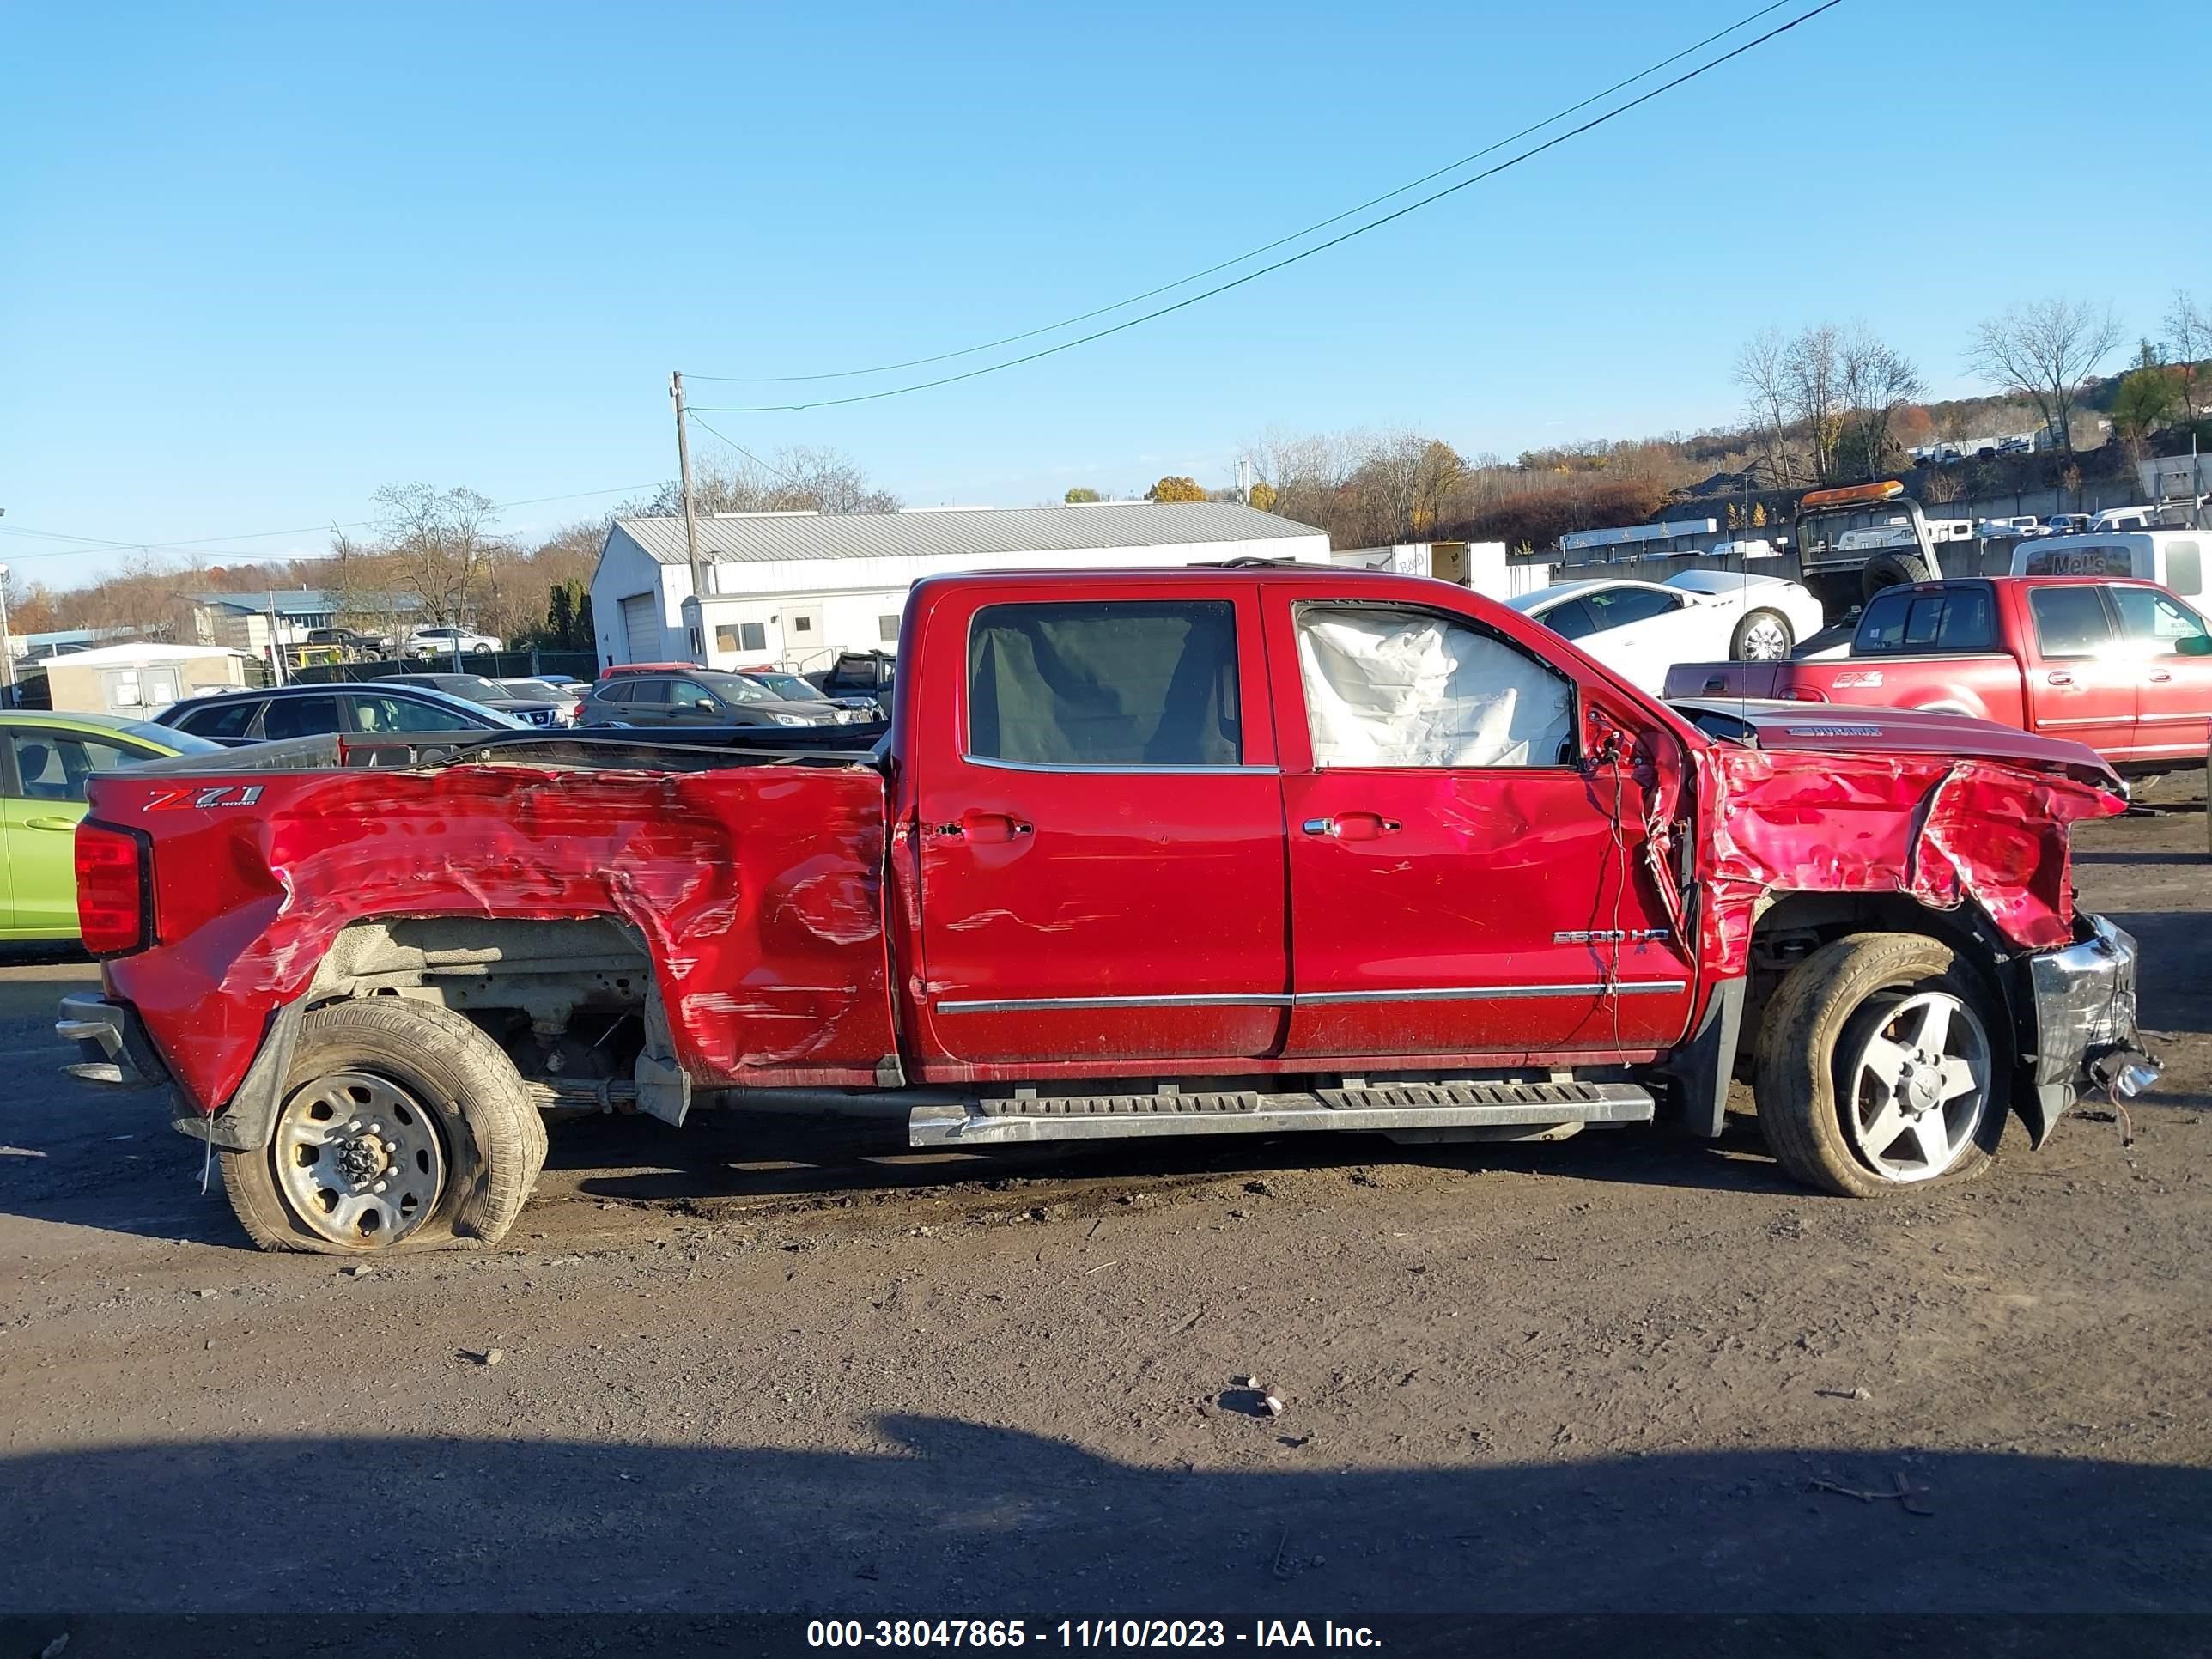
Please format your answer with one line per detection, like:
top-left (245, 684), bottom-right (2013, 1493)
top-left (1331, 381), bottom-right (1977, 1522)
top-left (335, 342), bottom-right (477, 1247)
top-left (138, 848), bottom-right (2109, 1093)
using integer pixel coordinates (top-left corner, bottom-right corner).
top-left (1698, 745), bottom-right (2126, 978)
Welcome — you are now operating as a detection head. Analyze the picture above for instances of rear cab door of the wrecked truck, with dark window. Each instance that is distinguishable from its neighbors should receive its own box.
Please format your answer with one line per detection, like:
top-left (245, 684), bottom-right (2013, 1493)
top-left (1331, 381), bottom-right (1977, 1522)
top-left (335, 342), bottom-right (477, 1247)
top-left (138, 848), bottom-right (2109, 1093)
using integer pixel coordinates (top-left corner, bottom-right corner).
top-left (907, 592), bottom-right (1290, 1075)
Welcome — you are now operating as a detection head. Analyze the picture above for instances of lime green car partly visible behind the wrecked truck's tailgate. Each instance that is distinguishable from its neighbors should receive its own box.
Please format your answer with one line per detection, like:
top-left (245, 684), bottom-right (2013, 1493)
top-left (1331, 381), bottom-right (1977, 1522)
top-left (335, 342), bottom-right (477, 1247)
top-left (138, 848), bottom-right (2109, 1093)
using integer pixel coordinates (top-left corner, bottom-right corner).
top-left (0, 708), bottom-right (222, 940)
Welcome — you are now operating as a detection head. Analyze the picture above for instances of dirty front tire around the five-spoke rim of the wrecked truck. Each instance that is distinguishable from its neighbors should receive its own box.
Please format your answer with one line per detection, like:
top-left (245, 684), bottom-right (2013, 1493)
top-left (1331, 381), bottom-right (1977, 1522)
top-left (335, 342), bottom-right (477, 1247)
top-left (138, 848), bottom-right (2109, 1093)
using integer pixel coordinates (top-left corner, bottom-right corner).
top-left (1752, 933), bottom-right (2013, 1199)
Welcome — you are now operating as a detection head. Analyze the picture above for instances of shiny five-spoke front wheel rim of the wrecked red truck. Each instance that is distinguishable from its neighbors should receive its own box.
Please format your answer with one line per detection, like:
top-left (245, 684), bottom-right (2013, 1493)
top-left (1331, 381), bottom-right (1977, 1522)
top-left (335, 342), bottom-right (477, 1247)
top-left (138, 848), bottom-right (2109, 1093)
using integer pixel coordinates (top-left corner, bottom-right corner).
top-left (1843, 991), bottom-right (1990, 1186)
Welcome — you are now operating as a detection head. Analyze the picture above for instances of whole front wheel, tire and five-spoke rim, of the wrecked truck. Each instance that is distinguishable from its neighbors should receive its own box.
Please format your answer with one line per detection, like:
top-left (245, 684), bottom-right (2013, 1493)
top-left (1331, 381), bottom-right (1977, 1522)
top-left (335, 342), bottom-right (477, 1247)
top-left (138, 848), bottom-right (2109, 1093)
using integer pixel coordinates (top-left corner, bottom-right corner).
top-left (1754, 933), bottom-right (2011, 1199)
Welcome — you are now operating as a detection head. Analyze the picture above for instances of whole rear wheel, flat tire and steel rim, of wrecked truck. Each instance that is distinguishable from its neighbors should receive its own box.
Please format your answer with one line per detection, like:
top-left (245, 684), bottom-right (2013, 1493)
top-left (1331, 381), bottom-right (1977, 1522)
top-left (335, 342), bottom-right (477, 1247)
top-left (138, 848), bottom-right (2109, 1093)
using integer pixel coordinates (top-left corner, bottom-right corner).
top-left (223, 998), bottom-right (546, 1256)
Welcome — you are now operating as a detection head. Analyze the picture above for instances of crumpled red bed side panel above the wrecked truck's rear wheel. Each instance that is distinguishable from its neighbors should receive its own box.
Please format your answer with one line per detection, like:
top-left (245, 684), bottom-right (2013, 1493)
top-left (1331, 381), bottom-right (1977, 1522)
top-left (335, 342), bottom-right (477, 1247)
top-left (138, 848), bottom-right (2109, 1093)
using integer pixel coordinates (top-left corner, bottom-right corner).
top-left (93, 765), bottom-right (896, 1110)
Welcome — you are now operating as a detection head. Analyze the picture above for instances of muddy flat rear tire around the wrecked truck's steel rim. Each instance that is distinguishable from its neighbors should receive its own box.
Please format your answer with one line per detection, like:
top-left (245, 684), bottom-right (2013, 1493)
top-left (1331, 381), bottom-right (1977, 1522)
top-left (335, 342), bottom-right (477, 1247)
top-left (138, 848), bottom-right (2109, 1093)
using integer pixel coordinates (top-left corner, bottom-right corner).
top-left (222, 998), bottom-right (546, 1256)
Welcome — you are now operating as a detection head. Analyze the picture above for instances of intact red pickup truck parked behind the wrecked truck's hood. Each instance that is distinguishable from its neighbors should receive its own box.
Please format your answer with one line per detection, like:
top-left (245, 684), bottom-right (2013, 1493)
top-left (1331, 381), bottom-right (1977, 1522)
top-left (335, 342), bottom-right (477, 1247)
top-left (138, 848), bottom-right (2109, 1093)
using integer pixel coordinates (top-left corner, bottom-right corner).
top-left (1666, 575), bottom-right (2212, 772)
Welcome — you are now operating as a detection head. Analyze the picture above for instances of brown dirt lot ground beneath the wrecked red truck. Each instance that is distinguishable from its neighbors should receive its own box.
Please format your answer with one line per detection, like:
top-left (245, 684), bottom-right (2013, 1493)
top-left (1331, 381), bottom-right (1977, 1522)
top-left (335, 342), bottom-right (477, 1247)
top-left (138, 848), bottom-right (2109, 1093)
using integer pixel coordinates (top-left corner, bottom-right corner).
top-left (0, 814), bottom-right (2212, 1620)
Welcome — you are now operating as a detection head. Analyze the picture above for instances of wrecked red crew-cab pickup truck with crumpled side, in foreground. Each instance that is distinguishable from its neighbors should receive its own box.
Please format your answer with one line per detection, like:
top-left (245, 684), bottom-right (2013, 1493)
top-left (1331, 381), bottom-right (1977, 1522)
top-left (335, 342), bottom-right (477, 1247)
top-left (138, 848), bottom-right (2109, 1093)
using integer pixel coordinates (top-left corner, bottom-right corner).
top-left (60, 566), bottom-right (2154, 1252)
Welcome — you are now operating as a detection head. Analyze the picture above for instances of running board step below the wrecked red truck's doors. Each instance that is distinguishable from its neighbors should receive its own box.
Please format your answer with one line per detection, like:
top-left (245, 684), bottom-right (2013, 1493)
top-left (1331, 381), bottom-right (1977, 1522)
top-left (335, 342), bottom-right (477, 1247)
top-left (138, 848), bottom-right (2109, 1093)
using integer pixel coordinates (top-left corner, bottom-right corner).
top-left (907, 1082), bottom-right (1655, 1146)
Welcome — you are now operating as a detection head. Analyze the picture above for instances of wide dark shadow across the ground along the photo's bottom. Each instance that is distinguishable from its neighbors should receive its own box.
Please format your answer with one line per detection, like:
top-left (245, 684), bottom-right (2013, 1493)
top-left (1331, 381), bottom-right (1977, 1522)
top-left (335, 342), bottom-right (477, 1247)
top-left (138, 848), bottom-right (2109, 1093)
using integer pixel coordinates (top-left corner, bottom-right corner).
top-left (0, 1424), bottom-right (2212, 1620)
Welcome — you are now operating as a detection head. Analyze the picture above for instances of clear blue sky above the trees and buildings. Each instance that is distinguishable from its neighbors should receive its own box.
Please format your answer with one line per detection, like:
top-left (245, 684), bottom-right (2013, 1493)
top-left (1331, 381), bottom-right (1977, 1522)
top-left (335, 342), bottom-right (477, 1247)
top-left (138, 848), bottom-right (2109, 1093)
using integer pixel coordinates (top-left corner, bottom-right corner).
top-left (0, 0), bottom-right (2212, 584)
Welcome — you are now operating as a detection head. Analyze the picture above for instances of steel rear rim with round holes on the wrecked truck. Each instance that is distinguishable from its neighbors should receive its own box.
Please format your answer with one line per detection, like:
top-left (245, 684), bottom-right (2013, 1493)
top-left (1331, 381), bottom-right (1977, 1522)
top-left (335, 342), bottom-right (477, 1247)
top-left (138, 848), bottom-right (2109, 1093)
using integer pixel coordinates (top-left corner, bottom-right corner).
top-left (270, 1071), bottom-right (445, 1249)
